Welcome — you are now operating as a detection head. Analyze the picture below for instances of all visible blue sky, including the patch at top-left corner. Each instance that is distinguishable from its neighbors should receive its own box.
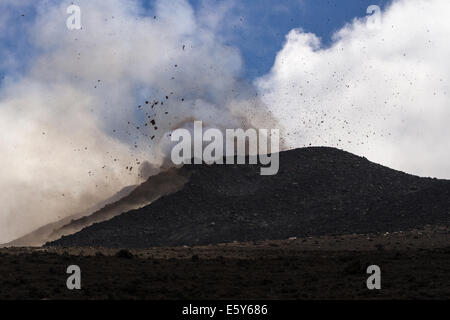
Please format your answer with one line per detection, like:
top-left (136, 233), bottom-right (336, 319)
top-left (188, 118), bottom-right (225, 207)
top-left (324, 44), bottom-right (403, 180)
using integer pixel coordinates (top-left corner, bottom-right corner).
top-left (0, 0), bottom-right (391, 81)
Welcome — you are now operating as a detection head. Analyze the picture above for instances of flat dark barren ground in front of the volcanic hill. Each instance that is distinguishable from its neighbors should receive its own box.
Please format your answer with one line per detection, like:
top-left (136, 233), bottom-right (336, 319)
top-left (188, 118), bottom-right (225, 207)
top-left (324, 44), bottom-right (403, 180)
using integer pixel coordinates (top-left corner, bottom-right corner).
top-left (0, 226), bottom-right (450, 299)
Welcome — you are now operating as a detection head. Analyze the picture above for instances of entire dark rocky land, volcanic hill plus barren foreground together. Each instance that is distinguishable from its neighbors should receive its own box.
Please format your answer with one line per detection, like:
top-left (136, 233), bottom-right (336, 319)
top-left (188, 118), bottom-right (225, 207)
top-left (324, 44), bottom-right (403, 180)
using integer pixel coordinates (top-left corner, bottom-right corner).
top-left (0, 148), bottom-right (450, 300)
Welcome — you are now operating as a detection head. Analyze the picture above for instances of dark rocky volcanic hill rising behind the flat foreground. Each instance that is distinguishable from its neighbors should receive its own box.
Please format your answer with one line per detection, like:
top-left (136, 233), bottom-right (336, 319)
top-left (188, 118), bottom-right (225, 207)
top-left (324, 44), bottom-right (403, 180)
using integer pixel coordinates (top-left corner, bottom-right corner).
top-left (48, 148), bottom-right (450, 248)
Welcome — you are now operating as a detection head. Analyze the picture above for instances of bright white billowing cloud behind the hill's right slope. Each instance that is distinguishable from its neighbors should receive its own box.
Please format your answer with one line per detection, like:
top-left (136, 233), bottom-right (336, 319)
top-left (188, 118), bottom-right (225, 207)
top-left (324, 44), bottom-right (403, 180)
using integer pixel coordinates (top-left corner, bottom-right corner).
top-left (257, 0), bottom-right (450, 178)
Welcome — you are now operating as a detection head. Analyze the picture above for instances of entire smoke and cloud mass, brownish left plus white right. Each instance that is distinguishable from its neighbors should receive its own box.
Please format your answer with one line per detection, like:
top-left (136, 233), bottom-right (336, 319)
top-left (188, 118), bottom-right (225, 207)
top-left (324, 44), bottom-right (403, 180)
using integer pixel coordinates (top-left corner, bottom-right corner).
top-left (0, 0), bottom-right (450, 242)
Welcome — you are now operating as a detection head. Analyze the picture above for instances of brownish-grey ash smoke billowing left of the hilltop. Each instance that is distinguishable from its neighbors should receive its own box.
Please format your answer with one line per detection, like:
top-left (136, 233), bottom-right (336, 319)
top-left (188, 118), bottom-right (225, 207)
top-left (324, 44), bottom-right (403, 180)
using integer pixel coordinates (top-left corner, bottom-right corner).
top-left (0, 0), bottom-right (274, 243)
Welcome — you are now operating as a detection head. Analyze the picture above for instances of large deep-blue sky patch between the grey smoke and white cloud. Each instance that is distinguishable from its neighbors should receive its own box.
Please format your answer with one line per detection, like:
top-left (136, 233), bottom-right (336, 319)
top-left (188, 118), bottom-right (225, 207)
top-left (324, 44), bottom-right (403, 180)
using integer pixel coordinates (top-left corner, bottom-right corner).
top-left (180, 0), bottom-right (391, 80)
